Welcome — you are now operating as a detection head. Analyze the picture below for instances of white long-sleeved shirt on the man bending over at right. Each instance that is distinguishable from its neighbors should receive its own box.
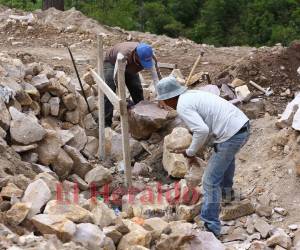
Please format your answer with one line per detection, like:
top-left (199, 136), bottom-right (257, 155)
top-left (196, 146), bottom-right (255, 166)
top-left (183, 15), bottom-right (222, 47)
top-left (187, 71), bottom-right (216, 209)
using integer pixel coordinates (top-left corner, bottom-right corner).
top-left (177, 90), bottom-right (249, 156)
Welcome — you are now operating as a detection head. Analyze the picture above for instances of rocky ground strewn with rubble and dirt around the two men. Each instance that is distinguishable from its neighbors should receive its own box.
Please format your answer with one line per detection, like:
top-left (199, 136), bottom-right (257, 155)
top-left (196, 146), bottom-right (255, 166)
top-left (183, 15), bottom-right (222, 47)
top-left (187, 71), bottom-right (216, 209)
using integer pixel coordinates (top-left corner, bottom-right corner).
top-left (0, 4), bottom-right (300, 250)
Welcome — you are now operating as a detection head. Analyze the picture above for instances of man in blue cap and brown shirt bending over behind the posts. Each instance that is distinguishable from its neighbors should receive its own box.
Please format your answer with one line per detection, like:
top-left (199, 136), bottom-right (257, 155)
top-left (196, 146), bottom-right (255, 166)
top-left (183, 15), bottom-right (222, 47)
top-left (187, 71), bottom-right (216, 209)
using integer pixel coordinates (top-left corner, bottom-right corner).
top-left (104, 42), bottom-right (159, 127)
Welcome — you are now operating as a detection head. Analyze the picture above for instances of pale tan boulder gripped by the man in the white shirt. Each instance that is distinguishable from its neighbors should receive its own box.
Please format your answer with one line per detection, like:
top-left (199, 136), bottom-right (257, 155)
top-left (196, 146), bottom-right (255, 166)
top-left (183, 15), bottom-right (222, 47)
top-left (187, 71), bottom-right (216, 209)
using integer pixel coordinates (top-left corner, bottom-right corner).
top-left (163, 127), bottom-right (192, 178)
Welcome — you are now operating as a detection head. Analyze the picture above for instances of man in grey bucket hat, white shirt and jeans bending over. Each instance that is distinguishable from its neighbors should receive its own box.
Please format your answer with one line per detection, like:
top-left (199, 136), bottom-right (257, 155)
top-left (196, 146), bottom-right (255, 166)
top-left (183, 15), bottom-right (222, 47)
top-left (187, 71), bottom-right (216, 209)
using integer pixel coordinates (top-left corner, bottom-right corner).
top-left (157, 77), bottom-right (249, 236)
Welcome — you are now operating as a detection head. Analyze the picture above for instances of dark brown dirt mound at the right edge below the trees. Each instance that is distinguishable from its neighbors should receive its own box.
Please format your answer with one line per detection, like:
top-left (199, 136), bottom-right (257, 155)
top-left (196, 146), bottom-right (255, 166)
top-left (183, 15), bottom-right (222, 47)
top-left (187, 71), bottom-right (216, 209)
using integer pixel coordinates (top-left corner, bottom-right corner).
top-left (218, 41), bottom-right (300, 115)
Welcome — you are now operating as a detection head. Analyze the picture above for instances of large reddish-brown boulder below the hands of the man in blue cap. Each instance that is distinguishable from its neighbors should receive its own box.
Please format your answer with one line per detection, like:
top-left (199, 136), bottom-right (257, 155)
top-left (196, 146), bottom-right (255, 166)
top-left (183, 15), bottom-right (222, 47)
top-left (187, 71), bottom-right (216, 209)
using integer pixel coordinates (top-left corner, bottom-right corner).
top-left (129, 101), bottom-right (169, 140)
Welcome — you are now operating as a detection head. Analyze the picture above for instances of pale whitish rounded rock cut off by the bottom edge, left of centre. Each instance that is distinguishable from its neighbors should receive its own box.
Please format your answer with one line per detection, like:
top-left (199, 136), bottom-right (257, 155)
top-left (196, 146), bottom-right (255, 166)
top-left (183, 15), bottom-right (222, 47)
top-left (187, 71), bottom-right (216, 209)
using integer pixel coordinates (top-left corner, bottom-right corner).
top-left (72, 223), bottom-right (105, 250)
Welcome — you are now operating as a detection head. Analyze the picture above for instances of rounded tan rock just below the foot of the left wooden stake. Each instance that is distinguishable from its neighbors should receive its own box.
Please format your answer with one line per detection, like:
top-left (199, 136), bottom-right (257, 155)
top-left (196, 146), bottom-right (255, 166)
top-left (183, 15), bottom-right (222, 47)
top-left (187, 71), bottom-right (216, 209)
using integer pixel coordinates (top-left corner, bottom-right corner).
top-left (84, 165), bottom-right (112, 187)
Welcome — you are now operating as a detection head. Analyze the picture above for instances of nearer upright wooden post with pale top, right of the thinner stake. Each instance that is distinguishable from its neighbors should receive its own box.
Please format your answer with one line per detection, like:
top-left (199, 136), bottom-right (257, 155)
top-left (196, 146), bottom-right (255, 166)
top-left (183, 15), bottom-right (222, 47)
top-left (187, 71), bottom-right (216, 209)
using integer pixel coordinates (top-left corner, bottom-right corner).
top-left (117, 54), bottom-right (132, 188)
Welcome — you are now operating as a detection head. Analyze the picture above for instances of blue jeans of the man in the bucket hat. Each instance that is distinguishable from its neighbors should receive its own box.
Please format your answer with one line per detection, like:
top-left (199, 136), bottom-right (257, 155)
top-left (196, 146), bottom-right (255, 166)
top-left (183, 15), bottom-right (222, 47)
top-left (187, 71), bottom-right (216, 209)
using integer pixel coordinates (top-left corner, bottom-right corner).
top-left (200, 122), bottom-right (250, 236)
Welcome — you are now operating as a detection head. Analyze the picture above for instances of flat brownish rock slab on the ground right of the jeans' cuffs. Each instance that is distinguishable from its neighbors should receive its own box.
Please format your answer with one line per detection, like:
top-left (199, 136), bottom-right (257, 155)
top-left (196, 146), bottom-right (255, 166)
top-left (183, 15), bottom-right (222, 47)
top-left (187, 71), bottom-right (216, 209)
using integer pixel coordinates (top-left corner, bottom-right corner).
top-left (220, 200), bottom-right (255, 221)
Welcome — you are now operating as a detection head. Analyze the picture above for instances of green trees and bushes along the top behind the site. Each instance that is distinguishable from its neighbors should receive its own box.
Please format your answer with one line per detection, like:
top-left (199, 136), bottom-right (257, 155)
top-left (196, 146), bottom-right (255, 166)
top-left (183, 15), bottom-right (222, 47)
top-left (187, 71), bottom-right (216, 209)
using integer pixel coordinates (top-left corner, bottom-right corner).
top-left (0, 0), bottom-right (300, 46)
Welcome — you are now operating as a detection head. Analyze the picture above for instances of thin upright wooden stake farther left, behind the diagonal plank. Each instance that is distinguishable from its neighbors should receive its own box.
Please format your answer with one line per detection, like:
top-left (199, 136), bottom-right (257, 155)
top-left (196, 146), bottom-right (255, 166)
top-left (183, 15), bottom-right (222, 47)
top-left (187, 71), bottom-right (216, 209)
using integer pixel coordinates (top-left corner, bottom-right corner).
top-left (97, 35), bottom-right (105, 160)
